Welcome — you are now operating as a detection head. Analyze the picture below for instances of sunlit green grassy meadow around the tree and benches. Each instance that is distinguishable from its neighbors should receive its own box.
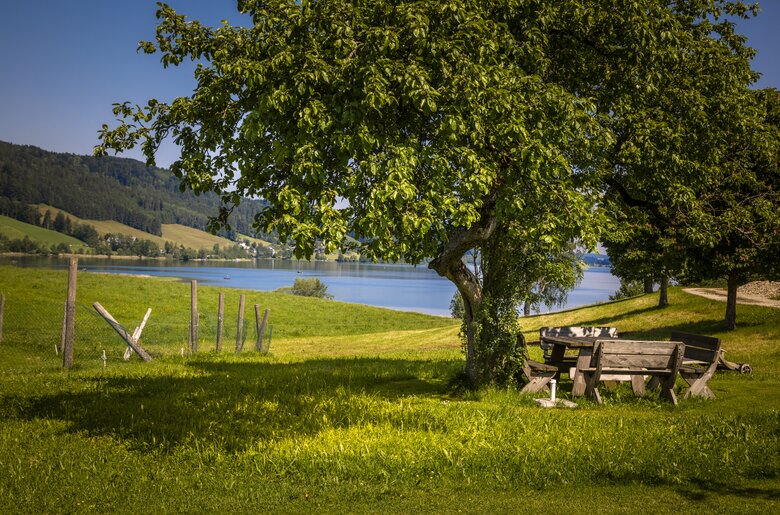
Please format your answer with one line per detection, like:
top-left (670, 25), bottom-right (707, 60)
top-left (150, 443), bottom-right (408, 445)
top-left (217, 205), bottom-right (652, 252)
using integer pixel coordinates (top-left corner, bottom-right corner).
top-left (0, 267), bottom-right (780, 513)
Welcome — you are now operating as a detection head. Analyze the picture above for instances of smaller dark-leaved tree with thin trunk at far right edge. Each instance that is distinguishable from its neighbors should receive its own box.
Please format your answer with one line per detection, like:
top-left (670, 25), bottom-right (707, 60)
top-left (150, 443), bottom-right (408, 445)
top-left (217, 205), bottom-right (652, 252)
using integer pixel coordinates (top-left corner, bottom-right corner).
top-left (686, 89), bottom-right (780, 329)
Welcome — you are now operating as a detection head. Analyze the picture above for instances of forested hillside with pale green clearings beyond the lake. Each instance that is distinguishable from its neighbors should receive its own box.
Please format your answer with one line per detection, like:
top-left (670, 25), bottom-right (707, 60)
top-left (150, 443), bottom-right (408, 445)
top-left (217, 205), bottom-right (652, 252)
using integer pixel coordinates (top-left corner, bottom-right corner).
top-left (0, 142), bottom-right (263, 236)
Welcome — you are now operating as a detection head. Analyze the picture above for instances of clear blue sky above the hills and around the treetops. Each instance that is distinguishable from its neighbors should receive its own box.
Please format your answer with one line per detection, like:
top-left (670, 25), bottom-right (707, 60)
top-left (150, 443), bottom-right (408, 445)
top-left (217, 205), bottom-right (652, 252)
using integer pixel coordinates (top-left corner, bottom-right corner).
top-left (0, 0), bottom-right (780, 166)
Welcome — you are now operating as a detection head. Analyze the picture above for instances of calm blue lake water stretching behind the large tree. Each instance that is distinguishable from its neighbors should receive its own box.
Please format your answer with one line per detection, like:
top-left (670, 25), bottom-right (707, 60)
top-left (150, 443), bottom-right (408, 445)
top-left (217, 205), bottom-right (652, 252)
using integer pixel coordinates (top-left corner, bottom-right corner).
top-left (0, 257), bottom-right (620, 316)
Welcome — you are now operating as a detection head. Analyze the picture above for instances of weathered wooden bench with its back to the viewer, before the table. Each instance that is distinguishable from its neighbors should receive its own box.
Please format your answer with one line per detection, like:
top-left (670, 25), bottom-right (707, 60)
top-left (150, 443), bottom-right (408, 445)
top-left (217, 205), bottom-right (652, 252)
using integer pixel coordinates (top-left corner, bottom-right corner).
top-left (581, 339), bottom-right (684, 406)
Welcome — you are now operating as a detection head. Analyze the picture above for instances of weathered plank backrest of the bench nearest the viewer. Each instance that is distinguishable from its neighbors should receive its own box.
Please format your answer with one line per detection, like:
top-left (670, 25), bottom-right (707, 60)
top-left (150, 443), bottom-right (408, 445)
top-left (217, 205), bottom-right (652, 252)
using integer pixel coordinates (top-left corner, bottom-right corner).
top-left (591, 340), bottom-right (683, 374)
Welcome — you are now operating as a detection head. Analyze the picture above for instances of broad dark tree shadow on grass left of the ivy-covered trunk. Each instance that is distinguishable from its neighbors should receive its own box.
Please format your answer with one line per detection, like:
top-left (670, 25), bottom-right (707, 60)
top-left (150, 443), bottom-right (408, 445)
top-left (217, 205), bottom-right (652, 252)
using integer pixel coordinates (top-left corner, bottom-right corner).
top-left (3, 358), bottom-right (459, 452)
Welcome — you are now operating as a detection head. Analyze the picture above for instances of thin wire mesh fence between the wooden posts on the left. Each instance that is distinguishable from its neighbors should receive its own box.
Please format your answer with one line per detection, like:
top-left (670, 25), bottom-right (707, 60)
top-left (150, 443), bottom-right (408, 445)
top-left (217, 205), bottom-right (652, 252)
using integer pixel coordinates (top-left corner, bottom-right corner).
top-left (0, 290), bottom-right (273, 362)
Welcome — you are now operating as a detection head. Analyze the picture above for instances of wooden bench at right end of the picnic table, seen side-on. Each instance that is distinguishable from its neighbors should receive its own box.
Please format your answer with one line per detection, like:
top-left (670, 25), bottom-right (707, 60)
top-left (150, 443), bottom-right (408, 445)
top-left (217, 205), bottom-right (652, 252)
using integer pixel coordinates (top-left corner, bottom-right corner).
top-left (672, 331), bottom-right (722, 399)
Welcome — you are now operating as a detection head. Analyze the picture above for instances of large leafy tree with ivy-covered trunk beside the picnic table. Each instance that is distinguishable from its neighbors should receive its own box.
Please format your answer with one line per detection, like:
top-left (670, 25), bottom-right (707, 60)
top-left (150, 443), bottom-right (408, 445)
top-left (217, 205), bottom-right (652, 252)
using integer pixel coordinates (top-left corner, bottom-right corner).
top-left (96, 0), bottom-right (760, 381)
